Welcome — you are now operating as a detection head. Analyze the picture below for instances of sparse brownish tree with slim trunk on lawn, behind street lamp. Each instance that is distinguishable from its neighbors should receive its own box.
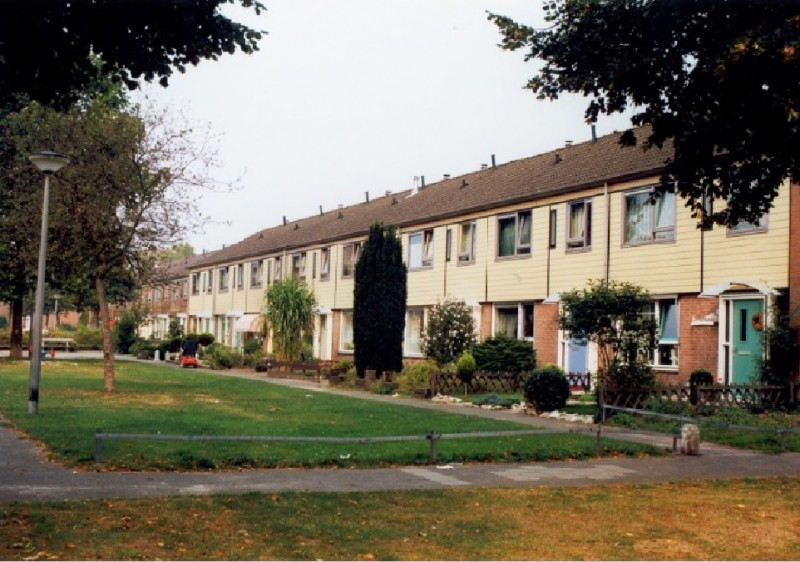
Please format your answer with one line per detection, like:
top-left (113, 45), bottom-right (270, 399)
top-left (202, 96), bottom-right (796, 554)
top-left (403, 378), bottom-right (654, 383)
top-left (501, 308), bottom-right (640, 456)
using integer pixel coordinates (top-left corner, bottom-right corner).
top-left (0, 96), bottom-right (214, 392)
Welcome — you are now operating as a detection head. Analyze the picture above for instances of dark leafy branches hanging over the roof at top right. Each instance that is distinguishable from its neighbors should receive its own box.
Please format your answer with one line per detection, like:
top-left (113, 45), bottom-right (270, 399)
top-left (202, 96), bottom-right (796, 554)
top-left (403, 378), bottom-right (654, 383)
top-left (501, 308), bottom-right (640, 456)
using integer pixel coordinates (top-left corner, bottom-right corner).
top-left (489, 0), bottom-right (800, 225)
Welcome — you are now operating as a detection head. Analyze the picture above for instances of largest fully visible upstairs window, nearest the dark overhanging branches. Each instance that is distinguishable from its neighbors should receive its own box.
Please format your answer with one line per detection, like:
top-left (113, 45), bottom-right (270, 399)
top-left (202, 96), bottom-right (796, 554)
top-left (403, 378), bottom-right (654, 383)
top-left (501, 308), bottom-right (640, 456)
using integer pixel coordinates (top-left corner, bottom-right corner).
top-left (624, 187), bottom-right (675, 244)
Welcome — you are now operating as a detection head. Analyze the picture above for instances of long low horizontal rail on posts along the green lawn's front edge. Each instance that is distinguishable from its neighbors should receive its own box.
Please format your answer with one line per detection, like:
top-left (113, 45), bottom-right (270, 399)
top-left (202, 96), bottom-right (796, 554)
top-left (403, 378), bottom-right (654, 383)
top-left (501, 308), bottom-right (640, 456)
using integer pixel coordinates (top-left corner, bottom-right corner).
top-left (94, 429), bottom-right (545, 466)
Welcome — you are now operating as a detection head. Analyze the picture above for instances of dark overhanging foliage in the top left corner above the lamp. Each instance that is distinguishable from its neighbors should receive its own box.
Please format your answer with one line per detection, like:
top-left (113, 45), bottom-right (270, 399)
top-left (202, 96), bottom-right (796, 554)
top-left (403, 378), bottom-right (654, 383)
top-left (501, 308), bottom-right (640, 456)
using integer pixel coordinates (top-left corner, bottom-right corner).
top-left (0, 0), bottom-right (264, 109)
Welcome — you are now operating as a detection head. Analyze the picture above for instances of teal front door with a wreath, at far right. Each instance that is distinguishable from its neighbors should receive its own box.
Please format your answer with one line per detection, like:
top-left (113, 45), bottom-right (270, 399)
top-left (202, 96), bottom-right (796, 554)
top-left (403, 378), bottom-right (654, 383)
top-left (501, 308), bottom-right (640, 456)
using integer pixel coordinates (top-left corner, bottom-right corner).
top-left (729, 299), bottom-right (764, 384)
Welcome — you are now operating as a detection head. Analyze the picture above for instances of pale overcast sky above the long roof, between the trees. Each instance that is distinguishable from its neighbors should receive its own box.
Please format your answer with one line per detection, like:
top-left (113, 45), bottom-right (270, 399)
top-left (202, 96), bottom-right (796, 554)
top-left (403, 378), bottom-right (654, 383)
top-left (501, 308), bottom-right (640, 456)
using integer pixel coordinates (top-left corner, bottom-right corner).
top-left (133, 0), bottom-right (628, 252)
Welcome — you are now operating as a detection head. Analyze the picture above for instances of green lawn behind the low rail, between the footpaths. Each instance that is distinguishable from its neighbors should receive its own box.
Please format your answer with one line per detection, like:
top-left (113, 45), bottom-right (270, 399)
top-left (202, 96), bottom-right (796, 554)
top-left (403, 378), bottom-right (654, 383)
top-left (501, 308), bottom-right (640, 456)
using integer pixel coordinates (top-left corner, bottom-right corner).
top-left (0, 361), bottom-right (657, 470)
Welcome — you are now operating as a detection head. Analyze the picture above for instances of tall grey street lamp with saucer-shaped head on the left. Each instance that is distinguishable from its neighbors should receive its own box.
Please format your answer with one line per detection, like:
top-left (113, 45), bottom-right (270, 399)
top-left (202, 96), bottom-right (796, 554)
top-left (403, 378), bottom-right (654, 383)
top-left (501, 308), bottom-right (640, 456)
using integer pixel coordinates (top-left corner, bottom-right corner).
top-left (28, 151), bottom-right (69, 414)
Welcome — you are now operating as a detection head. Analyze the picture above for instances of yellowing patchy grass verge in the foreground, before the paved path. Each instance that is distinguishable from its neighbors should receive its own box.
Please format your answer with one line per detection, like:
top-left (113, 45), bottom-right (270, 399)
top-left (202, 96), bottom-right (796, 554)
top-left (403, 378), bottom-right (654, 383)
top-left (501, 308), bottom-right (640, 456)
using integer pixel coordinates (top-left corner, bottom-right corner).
top-left (0, 479), bottom-right (800, 560)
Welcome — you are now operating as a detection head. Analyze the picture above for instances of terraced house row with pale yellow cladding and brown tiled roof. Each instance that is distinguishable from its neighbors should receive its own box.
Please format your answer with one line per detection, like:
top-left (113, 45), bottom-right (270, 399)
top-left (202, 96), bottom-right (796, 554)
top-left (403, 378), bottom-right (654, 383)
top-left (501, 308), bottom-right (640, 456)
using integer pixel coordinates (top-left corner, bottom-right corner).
top-left (142, 130), bottom-right (800, 383)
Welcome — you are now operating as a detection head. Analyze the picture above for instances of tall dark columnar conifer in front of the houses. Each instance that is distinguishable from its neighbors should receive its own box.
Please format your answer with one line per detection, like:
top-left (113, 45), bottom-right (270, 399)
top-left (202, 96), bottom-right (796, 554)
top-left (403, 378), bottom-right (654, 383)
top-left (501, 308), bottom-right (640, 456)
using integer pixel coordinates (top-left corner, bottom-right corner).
top-left (353, 223), bottom-right (407, 377)
